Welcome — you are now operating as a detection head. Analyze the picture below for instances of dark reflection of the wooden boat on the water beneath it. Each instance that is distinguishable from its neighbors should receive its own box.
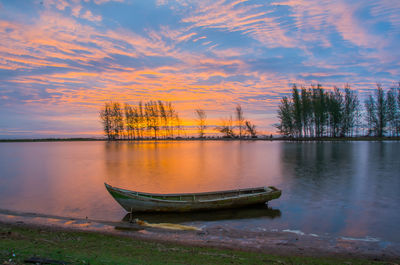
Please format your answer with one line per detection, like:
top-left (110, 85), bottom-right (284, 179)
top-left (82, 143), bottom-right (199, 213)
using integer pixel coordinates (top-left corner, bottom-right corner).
top-left (122, 205), bottom-right (281, 224)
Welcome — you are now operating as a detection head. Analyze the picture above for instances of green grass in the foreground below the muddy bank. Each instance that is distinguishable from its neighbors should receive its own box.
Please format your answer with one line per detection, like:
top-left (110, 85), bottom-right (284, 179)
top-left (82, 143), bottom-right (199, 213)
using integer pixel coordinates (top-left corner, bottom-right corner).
top-left (0, 224), bottom-right (393, 264)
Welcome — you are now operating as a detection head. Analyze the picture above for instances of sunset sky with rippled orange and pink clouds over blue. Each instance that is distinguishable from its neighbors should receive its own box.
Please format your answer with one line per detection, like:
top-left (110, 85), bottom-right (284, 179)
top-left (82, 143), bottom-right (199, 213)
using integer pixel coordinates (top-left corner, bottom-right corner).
top-left (0, 0), bottom-right (400, 136)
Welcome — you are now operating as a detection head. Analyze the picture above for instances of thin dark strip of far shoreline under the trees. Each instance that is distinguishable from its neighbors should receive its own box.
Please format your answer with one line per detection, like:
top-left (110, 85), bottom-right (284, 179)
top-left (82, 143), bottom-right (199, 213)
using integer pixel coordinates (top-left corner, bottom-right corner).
top-left (0, 136), bottom-right (400, 143)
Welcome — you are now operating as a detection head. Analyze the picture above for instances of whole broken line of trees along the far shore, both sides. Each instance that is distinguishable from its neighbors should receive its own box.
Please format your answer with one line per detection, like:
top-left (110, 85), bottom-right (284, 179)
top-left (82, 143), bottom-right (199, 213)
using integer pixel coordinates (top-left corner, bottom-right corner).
top-left (100, 83), bottom-right (400, 140)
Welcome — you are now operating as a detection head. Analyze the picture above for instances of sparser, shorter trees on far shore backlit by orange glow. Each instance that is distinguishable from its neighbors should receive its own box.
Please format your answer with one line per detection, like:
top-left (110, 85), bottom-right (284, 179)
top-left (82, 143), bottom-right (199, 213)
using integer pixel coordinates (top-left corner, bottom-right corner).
top-left (100, 100), bottom-right (257, 140)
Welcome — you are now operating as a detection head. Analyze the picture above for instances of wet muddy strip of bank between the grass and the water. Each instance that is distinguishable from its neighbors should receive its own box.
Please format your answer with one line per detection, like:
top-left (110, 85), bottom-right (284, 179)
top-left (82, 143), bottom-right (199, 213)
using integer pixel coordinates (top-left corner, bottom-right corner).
top-left (0, 207), bottom-right (400, 261)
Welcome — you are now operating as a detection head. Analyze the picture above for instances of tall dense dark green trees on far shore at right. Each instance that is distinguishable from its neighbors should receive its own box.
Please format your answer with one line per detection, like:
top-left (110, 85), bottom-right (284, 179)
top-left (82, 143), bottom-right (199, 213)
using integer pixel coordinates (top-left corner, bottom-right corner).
top-left (275, 83), bottom-right (400, 138)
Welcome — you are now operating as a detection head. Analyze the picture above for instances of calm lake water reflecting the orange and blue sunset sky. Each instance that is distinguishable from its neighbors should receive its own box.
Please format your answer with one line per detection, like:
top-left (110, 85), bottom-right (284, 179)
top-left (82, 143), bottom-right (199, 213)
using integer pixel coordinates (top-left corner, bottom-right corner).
top-left (0, 141), bottom-right (400, 242)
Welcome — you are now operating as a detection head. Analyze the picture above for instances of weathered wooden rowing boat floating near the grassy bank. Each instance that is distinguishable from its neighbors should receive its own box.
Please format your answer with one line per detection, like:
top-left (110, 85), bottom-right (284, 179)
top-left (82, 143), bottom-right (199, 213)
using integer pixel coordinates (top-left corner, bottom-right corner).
top-left (104, 183), bottom-right (281, 212)
